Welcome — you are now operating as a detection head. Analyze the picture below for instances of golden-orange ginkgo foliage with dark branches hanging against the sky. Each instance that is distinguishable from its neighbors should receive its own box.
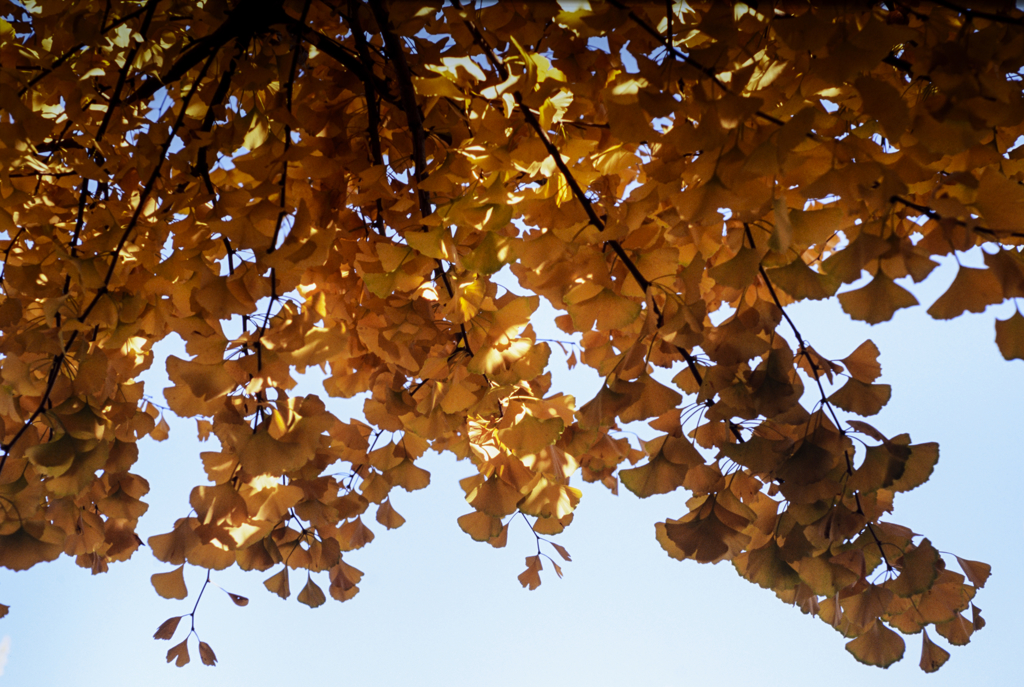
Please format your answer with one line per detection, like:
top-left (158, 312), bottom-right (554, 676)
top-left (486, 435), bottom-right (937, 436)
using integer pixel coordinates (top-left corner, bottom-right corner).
top-left (0, 0), bottom-right (1024, 672)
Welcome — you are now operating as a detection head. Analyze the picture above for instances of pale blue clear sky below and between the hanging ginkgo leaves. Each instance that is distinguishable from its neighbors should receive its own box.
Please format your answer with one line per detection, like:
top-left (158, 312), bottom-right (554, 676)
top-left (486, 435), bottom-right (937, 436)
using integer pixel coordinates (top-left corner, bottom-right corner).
top-left (0, 244), bottom-right (1024, 687)
